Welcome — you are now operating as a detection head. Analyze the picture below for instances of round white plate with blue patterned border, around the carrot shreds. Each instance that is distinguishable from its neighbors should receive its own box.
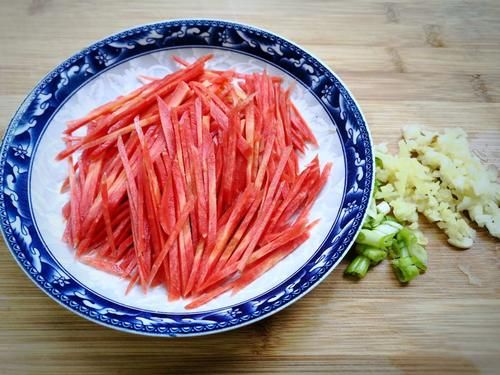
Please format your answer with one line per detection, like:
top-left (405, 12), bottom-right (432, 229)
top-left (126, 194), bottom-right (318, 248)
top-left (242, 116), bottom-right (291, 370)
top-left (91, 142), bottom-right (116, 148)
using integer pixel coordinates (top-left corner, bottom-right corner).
top-left (0, 20), bottom-right (373, 336)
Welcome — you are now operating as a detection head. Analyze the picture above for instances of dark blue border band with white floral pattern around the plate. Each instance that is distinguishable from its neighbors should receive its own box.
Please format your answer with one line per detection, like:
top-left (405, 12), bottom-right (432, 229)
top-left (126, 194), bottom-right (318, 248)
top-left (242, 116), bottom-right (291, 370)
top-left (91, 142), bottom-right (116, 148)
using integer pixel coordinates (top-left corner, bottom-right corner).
top-left (0, 20), bottom-right (374, 336)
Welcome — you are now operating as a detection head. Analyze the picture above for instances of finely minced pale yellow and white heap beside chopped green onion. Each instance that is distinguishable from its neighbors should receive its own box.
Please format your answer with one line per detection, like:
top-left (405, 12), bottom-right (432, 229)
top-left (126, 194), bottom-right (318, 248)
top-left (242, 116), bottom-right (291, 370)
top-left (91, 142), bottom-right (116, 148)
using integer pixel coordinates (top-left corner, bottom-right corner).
top-left (375, 126), bottom-right (500, 249)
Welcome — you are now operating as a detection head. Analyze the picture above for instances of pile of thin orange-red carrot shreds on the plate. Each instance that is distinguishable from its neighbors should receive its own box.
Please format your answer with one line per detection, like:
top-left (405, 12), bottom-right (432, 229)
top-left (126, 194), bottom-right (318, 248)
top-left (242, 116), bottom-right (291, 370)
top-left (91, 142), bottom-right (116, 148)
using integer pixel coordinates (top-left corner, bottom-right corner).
top-left (57, 55), bottom-right (331, 308)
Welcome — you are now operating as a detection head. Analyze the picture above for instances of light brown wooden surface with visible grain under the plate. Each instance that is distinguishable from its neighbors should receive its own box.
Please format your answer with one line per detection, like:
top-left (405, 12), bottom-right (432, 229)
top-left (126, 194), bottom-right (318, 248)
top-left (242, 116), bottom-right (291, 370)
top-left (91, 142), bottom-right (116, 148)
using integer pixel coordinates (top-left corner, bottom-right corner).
top-left (0, 0), bottom-right (500, 374)
